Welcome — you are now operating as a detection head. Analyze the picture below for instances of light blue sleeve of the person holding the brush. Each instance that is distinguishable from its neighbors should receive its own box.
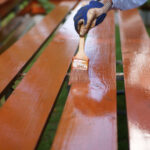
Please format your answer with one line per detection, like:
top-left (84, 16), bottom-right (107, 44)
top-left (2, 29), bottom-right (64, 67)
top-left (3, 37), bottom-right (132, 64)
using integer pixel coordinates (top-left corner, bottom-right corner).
top-left (112, 0), bottom-right (147, 10)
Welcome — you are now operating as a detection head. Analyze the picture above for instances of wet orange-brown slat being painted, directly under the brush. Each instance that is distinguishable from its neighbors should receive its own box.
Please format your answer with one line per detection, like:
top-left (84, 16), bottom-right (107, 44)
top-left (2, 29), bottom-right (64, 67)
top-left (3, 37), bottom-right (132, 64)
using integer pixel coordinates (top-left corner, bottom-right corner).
top-left (52, 12), bottom-right (117, 150)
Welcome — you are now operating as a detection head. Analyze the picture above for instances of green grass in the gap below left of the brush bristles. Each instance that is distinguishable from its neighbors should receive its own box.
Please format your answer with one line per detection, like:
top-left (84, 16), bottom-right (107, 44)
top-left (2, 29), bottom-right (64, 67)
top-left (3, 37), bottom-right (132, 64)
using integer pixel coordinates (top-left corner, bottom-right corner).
top-left (36, 78), bottom-right (69, 150)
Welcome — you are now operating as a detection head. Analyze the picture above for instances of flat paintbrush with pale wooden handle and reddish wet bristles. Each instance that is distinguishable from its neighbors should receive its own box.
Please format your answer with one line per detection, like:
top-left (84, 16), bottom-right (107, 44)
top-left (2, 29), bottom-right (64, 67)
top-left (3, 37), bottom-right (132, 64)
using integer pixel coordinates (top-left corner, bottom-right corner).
top-left (69, 37), bottom-right (89, 85)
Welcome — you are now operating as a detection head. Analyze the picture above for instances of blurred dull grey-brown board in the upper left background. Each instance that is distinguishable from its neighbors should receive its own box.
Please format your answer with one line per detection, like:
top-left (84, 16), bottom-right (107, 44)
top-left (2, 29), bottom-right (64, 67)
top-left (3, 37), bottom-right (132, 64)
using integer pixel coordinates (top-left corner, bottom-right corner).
top-left (0, 16), bottom-right (35, 54)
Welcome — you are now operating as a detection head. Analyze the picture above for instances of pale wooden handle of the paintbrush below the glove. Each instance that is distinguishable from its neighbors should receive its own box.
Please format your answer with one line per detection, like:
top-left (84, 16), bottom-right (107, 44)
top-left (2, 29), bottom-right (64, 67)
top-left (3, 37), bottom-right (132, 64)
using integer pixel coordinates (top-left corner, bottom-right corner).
top-left (75, 37), bottom-right (88, 60)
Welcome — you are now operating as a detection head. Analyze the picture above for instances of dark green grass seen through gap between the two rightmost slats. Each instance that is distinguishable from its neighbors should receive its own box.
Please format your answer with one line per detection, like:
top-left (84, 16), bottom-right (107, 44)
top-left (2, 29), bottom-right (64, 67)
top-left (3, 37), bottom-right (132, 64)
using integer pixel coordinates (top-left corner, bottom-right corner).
top-left (116, 26), bottom-right (129, 150)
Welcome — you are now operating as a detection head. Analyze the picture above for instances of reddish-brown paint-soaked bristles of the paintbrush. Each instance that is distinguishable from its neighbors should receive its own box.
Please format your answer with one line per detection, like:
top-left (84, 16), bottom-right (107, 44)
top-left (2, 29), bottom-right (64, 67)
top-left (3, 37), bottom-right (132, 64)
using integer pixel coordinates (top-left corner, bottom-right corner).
top-left (69, 68), bottom-right (89, 85)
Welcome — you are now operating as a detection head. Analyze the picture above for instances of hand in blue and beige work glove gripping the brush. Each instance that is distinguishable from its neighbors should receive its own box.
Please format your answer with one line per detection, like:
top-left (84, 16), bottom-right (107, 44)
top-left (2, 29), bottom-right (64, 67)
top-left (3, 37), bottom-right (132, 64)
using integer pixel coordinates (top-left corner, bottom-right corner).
top-left (74, 0), bottom-right (112, 36)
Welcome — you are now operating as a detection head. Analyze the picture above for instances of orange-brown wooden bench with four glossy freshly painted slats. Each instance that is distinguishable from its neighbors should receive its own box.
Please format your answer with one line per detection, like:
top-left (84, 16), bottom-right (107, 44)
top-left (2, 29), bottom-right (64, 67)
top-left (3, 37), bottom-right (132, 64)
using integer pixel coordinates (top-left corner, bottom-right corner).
top-left (0, 1), bottom-right (150, 150)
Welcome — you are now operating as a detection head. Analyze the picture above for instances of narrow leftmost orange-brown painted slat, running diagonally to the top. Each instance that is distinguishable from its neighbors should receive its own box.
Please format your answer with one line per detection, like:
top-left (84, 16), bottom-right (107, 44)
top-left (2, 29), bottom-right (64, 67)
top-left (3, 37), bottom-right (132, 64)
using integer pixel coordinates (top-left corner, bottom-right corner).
top-left (0, 2), bottom-right (75, 93)
